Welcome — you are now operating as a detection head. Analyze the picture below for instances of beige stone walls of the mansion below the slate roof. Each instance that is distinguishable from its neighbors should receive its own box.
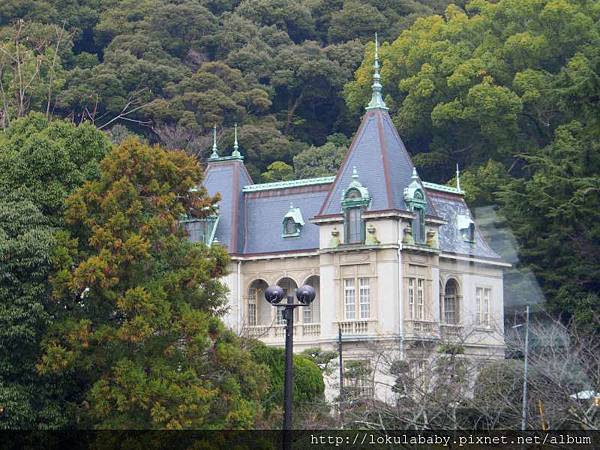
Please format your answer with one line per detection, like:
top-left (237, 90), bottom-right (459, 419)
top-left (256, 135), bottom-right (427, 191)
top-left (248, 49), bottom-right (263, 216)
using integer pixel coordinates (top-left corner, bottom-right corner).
top-left (224, 217), bottom-right (504, 400)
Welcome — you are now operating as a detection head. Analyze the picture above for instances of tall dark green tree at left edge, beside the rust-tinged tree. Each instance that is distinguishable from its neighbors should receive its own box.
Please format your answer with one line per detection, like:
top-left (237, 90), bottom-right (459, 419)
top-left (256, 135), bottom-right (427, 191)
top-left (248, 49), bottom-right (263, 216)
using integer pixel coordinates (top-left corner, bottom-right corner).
top-left (0, 114), bottom-right (109, 429)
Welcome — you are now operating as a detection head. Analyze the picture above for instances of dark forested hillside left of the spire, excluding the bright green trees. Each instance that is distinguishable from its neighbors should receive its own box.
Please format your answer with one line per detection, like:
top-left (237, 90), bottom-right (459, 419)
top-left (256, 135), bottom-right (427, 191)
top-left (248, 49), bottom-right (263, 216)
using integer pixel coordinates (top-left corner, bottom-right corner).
top-left (0, 0), bottom-right (460, 181)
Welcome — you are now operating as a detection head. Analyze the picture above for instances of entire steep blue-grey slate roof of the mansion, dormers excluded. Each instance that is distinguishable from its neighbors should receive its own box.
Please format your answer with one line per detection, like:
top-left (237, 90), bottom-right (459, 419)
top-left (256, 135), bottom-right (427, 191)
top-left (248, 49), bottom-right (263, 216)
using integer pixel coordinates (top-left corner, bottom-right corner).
top-left (204, 113), bottom-right (500, 259)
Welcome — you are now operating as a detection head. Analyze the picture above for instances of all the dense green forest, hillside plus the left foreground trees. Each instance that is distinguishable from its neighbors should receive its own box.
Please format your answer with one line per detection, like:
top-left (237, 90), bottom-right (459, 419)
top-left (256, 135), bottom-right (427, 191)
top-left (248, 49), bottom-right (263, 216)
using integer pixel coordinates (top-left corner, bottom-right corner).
top-left (0, 0), bottom-right (600, 428)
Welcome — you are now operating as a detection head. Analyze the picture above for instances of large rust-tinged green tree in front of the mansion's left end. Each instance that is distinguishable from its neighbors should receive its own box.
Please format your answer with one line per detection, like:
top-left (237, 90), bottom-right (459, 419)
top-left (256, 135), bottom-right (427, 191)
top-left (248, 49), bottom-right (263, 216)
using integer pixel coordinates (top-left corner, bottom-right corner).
top-left (38, 140), bottom-right (267, 429)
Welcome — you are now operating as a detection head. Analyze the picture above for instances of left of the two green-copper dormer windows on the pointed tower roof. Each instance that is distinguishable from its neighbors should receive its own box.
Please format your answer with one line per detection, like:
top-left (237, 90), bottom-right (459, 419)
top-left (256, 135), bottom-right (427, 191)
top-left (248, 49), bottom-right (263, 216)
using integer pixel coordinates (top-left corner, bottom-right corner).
top-left (342, 167), bottom-right (371, 244)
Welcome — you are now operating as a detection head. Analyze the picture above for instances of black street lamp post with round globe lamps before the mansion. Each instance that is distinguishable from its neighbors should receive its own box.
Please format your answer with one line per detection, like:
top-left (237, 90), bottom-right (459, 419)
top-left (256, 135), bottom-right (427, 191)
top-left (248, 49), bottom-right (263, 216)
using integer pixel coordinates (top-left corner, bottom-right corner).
top-left (265, 285), bottom-right (317, 450)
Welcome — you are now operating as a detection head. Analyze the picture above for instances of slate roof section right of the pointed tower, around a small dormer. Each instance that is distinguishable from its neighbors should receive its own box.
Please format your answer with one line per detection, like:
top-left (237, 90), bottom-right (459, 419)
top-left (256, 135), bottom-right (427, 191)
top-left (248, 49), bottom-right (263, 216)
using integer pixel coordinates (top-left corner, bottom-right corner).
top-left (427, 189), bottom-right (500, 259)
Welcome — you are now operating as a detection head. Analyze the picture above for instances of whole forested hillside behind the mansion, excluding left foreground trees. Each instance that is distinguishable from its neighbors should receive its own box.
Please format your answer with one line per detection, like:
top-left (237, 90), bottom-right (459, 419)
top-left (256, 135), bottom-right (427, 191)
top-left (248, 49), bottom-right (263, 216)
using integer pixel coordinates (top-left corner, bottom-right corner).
top-left (0, 0), bottom-right (600, 328)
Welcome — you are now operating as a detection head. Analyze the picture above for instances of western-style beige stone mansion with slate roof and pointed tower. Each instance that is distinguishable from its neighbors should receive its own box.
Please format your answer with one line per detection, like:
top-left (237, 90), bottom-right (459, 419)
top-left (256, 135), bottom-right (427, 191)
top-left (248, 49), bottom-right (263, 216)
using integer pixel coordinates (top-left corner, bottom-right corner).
top-left (186, 41), bottom-right (509, 400)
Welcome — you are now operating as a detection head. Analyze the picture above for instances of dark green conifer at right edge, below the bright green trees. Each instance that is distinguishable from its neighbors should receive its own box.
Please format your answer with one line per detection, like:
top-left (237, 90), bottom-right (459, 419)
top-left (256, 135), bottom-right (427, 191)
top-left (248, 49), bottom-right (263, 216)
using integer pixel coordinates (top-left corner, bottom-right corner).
top-left (500, 122), bottom-right (600, 325)
